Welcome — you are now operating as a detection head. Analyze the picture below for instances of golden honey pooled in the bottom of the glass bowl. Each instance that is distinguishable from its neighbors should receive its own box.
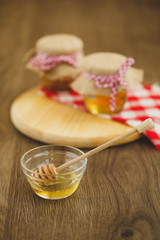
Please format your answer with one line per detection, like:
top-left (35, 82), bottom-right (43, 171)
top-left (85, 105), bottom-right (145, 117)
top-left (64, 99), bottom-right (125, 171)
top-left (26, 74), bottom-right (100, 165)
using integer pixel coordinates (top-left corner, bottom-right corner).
top-left (28, 174), bottom-right (81, 199)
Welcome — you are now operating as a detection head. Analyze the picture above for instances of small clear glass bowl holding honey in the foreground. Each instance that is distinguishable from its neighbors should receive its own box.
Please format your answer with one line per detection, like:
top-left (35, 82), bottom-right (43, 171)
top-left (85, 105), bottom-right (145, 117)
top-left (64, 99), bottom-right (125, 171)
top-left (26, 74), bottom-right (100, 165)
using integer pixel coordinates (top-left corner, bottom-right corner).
top-left (21, 145), bottom-right (87, 200)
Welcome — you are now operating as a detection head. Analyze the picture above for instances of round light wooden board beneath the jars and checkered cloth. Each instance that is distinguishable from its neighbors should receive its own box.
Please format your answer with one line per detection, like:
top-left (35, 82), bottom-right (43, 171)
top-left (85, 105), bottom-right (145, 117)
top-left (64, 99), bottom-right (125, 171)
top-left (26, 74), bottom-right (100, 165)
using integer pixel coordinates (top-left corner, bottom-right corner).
top-left (10, 87), bottom-right (140, 148)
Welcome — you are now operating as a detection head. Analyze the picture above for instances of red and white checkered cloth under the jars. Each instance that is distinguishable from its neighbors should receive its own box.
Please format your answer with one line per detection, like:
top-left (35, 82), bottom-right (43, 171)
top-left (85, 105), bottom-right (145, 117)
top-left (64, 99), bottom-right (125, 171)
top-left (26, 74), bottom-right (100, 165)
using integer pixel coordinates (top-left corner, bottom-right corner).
top-left (39, 84), bottom-right (160, 151)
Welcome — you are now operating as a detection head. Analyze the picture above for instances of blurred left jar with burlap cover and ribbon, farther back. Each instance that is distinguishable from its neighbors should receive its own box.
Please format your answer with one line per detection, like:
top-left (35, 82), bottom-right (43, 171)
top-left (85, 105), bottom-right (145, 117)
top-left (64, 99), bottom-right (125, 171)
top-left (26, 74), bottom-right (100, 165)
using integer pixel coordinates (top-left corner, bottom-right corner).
top-left (24, 34), bottom-right (83, 91)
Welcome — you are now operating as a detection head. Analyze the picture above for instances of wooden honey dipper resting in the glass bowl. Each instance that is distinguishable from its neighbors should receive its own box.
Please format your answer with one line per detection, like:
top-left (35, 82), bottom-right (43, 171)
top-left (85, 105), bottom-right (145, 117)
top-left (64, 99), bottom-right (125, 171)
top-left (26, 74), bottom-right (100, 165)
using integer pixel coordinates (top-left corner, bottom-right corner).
top-left (33, 118), bottom-right (154, 180)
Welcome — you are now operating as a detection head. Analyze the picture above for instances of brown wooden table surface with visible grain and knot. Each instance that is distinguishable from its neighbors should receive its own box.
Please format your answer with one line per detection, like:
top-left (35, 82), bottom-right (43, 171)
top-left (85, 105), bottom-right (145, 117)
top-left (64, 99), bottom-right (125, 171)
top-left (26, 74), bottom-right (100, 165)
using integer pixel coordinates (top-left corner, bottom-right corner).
top-left (0, 0), bottom-right (160, 240)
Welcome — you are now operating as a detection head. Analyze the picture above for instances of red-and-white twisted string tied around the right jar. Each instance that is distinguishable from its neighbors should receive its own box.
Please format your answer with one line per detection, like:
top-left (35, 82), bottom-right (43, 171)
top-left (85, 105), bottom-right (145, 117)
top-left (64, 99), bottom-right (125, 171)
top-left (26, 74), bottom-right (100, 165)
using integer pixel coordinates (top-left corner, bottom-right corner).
top-left (82, 57), bottom-right (135, 111)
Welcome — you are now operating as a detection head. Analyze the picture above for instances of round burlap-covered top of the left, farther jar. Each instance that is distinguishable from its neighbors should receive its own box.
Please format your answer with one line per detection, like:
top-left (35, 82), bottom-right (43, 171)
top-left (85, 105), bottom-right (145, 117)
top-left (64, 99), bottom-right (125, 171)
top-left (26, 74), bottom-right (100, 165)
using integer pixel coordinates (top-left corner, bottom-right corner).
top-left (36, 34), bottom-right (83, 55)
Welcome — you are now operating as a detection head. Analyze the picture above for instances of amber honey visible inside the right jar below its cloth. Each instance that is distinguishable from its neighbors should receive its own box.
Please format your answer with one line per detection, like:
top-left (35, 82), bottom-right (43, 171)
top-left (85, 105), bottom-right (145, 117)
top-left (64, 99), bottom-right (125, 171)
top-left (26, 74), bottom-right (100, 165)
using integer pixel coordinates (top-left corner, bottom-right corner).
top-left (84, 90), bottom-right (127, 114)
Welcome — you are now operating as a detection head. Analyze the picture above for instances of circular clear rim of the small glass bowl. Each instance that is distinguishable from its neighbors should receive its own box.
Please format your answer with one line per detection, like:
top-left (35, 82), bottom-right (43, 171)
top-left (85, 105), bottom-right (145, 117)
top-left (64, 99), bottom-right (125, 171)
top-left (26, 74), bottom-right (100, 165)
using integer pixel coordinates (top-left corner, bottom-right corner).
top-left (20, 144), bottom-right (88, 176)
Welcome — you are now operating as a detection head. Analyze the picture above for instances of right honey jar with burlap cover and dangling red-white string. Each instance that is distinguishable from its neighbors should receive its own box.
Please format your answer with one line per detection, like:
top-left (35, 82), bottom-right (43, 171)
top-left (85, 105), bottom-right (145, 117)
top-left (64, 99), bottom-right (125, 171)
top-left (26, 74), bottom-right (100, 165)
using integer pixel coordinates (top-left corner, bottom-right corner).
top-left (71, 52), bottom-right (143, 114)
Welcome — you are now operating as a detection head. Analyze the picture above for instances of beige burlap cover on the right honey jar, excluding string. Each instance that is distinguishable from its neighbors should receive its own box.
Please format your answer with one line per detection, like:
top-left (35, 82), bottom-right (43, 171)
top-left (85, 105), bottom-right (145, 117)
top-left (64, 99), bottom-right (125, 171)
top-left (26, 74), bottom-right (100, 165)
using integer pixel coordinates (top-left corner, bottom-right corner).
top-left (71, 52), bottom-right (143, 96)
